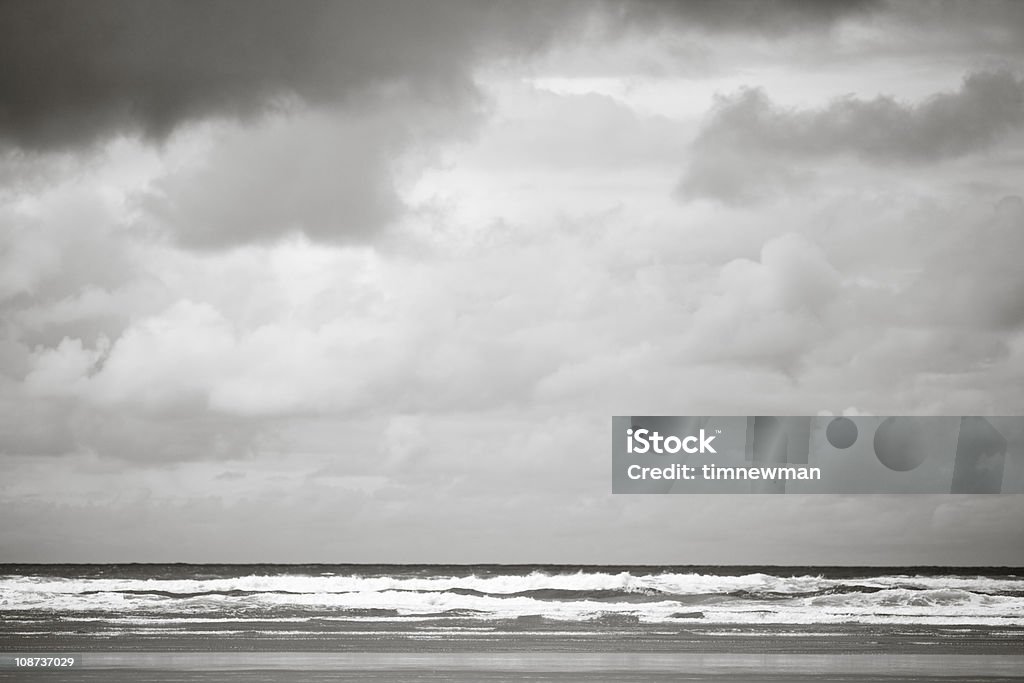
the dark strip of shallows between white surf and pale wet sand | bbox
[0,620,1024,655]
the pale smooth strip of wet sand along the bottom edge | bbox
[0,651,1024,681]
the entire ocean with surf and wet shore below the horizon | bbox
[0,564,1024,681]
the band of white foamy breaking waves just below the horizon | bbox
[0,571,1024,626]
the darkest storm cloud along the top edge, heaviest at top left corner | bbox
[0,0,869,148]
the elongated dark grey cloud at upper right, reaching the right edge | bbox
[680,71,1024,202]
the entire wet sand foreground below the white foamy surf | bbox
[0,624,1024,682]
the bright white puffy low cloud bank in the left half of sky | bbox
[25,301,403,415]
